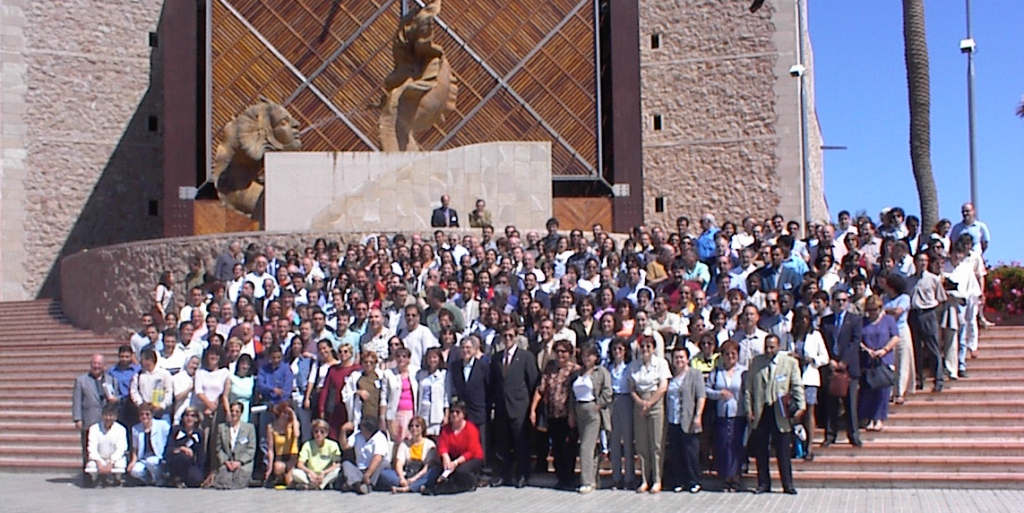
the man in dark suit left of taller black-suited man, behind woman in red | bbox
[447,334,490,452]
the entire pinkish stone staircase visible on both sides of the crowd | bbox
[0,301,1024,488]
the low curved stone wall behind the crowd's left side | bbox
[60,229,480,337]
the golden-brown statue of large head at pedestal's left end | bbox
[213,101,302,222]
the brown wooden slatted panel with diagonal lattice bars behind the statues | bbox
[210,0,599,176]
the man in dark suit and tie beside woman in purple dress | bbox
[820,290,863,447]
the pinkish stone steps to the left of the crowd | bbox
[0,300,119,471]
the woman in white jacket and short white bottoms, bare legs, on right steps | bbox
[782,305,828,461]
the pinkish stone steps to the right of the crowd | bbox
[794,328,1024,489]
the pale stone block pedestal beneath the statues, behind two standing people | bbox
[265,142,552,231]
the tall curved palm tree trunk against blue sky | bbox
[903,0,939,230]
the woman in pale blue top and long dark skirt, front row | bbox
[707,340,746,491]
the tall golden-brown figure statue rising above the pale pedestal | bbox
[378,0,459,152]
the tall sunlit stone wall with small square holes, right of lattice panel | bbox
[640,0,824,226]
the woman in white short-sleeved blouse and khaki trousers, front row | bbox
[630,336,672,494]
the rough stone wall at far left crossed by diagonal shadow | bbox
[0,0,164,300]
